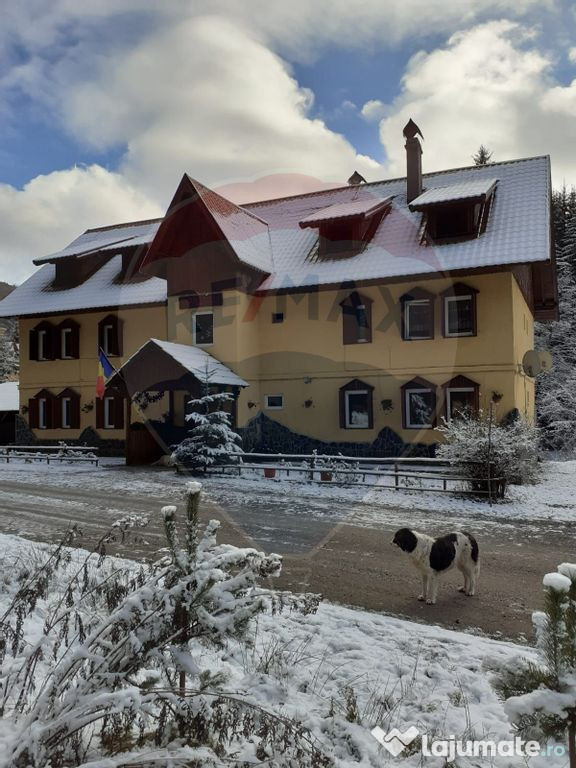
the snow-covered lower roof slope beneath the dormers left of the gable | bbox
[0,256,166,317]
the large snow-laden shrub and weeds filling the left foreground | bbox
[0,483,329,768]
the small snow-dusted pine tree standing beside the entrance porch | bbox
[172,370,242,472]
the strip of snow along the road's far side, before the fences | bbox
[0,459,576,527]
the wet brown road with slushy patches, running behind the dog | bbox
[0,480,576,640]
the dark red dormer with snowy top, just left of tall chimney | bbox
[300,194,391,258]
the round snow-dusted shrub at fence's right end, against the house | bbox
[437,412,540,492]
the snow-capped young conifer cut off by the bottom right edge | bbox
[495,563,576,765]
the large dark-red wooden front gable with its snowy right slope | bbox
[142,174,273,274]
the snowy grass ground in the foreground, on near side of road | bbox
[0,534,567,768]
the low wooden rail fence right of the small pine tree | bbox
[202,453,506,499]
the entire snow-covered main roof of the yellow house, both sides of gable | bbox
[0,156,550,317]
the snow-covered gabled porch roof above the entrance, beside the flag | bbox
[109,339,248,396]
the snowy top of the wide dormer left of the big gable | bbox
[34,219,162,264]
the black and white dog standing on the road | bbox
[392,528,480,605]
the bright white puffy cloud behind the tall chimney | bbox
[380,21,576,184]
